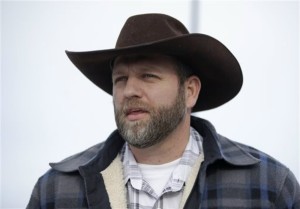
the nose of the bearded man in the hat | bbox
[123,76,142,98]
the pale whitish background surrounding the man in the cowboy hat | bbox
[0,0,300,208]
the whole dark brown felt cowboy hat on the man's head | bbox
[66,14,243,112]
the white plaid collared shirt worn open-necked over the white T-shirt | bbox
[121,127,203,209]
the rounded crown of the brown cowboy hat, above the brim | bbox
[116,14,189,48]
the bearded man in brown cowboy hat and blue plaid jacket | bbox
[27,14,300,209]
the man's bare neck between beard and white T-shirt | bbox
[130,114,190,165]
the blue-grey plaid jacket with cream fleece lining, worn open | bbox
[27,117,300,209]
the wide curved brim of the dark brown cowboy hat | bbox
[66,34,243,112]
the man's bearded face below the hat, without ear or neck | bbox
[112,55,186,148]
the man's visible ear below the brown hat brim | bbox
[185,76,201,109]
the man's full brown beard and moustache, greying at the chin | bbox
[114,87,186,148]
